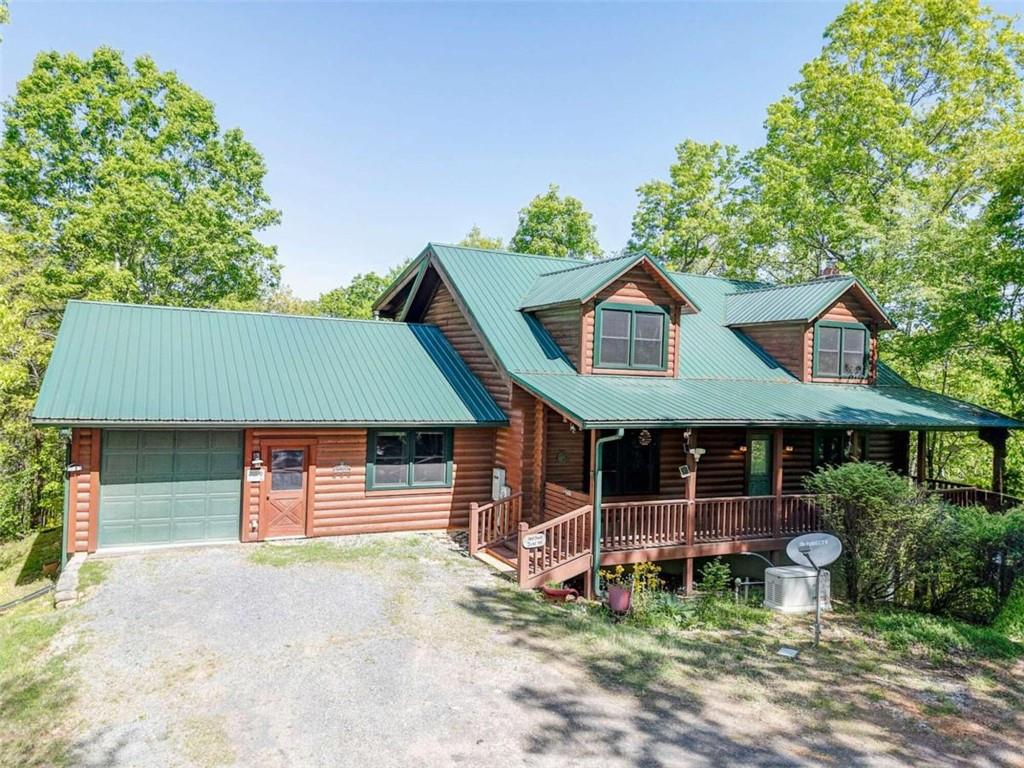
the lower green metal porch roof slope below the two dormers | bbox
[514,374,1024,429]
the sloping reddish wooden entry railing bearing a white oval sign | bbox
[516,504,594,588]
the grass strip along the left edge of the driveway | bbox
[0,530,72,768]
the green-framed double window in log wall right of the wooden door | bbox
[367,429,452,489]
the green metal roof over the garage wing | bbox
[33,301,507,425]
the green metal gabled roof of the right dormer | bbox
[725,276,892,326]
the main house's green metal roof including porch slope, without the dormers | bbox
[423,244,1024,429]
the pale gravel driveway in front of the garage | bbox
[61,535,999,768]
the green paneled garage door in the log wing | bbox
[98,430,242,547]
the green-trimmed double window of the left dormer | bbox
[594,302,669,371]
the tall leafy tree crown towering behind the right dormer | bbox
[753,0,1024,307]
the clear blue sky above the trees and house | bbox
[0,0,933,298]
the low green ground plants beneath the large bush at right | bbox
[857,610,1024,659]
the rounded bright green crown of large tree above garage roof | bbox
[0,48,280,305]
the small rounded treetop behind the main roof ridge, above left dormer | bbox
[509,184,601,259]
